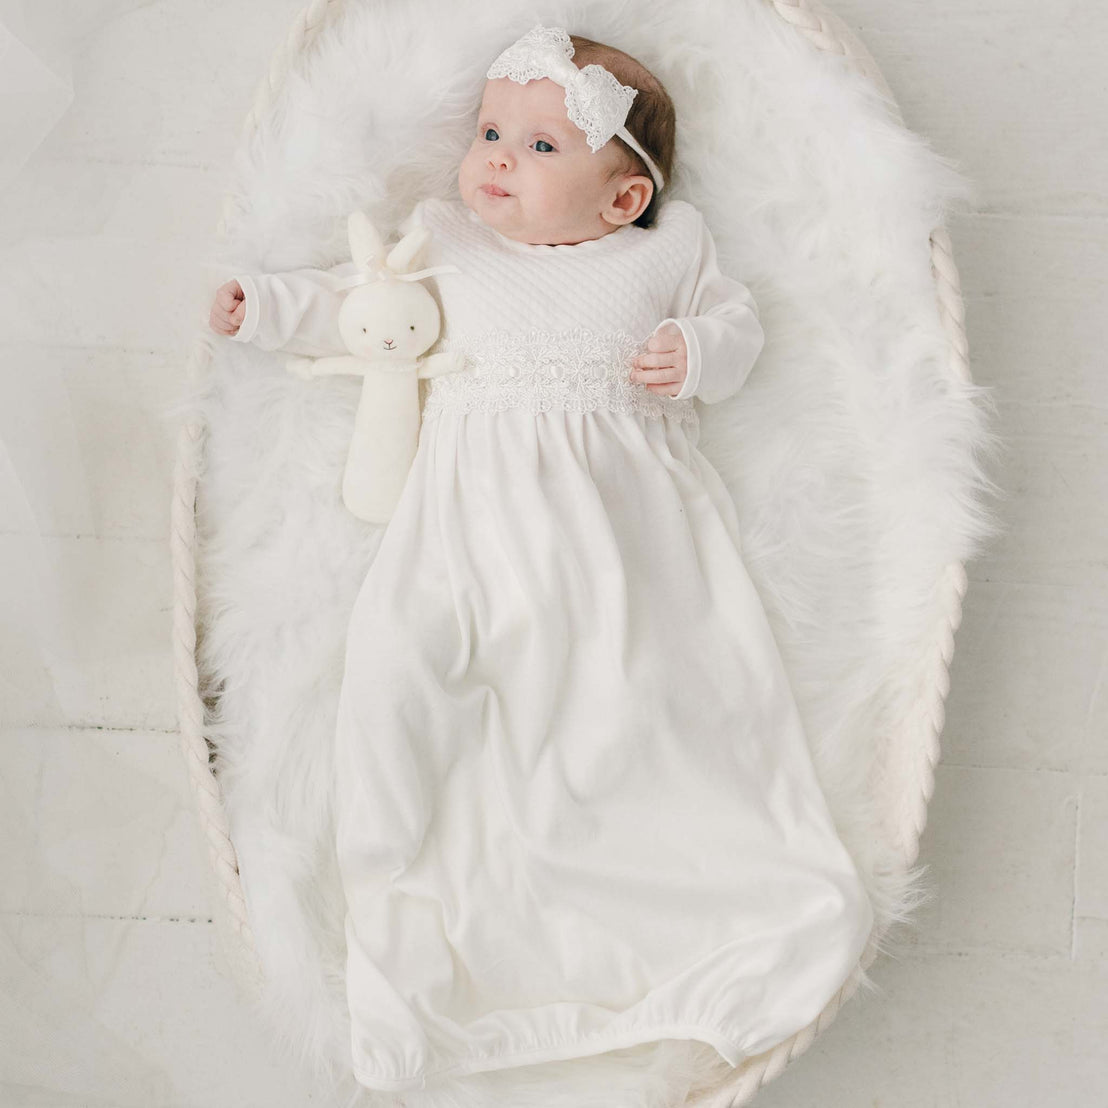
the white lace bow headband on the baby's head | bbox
[485,23,665,191]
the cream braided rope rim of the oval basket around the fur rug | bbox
[171,0,971,1108]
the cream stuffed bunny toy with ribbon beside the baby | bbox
[285,212,465,523]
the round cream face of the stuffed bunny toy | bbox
[338,278,441,361]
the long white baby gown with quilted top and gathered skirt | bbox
[236,199,873,1090]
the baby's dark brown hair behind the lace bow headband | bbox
[570,34,677,227]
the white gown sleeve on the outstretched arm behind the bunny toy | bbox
[230,201,422,358]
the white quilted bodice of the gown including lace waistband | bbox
[413,198,699,420]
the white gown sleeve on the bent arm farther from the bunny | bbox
[655,215,766,404]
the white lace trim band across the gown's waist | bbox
[423,327,697,421]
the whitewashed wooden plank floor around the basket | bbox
[0,0,1108,1108]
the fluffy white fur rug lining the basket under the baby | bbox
[168,0,995,1108]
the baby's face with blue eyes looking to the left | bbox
[458,76,649,244]
